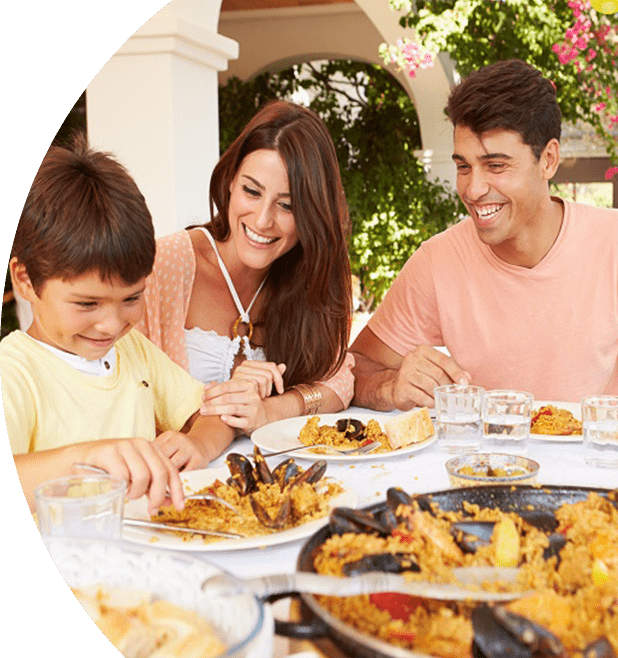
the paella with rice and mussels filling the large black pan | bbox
[312,489,618,658]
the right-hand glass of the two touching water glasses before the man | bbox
[482,390,534,455]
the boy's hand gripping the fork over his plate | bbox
[81,438,184,514]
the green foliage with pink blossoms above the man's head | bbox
[381,0,618,161]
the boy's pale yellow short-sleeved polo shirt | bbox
[0,330,204,454]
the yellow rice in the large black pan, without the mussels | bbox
[314,493,618,658]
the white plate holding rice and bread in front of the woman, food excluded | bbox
[251,412,436,462]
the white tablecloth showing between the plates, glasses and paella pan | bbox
[152,407,618,658]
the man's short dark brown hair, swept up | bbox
[446,59,562,160]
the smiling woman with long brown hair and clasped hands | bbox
[138,101,354,433]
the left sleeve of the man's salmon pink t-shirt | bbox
[368,245,443,356]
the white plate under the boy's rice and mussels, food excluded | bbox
[122,466,357,552]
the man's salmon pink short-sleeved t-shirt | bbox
[369,196,618,402]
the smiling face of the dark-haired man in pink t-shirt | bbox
[453,126,557,257]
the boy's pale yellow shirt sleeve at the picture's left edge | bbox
[1,359,36,455]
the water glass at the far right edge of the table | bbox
[582,395,618,468]
